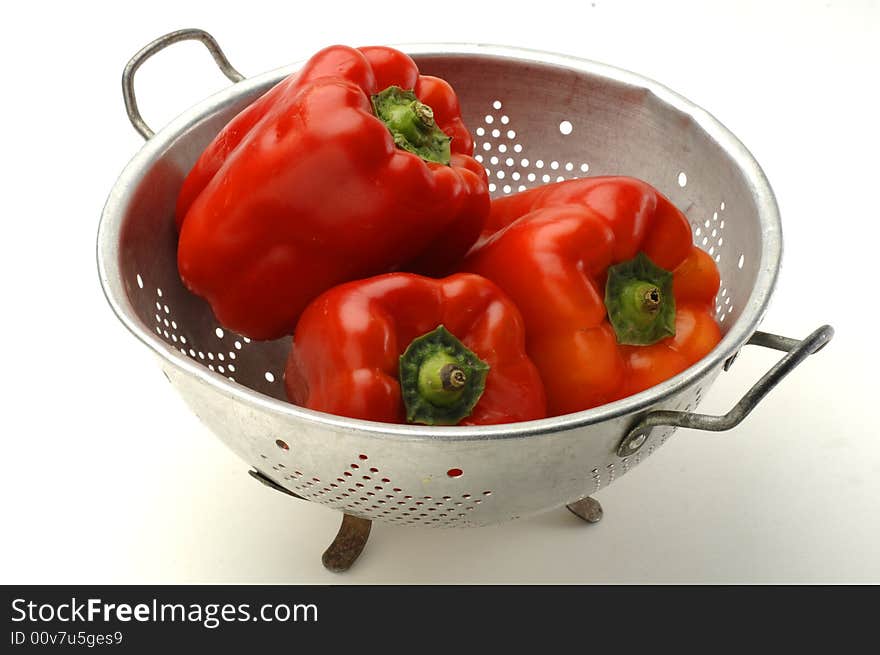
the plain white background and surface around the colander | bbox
[0,0,880,583]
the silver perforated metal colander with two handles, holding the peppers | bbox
[98,30,833,572]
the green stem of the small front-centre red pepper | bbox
[398,325,489,425]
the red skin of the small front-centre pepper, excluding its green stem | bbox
[284,273,546,425]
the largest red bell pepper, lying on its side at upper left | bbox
[176,46,489,339]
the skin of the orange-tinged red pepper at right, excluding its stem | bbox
[462,177,721,415]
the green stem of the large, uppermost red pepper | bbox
[371,86,451,165]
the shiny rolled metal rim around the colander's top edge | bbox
[96,43,782,441]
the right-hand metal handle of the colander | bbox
[617,325,834,457]
